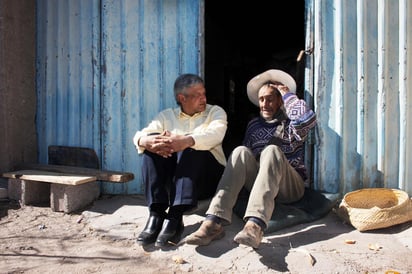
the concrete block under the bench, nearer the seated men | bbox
[50,182,100,213]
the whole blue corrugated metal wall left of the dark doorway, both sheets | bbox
[37,0,203,194]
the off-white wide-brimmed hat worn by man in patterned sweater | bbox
[247,69,296,106]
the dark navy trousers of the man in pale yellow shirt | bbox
[142,148,224,209]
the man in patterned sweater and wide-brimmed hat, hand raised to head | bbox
[184,69,316,248]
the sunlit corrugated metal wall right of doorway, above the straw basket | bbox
[306,0,412,195]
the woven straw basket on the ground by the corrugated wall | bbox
[337,188,412,231]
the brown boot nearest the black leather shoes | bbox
[185,220,225,245]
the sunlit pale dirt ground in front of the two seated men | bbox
[0,196,412,273]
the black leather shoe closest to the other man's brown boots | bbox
[155,219,184,247]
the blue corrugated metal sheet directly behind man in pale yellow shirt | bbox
[101,1,201,193]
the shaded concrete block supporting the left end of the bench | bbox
[8,179,50,205]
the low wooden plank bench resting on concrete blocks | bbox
[1,164,134,213]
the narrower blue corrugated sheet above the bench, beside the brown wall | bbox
[36,0,101,163]
